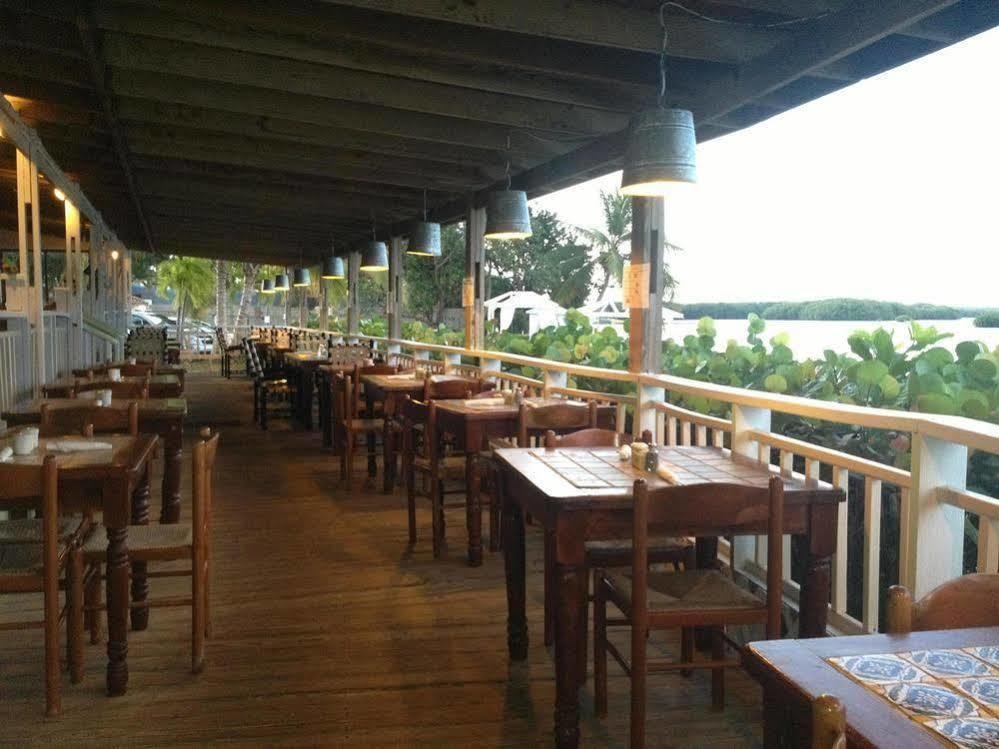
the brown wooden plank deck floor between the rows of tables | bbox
[0,375,761,748]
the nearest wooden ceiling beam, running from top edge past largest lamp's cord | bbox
[316,0,784,63]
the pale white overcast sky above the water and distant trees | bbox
[533,29,999,306]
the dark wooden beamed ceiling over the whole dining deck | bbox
[0,0,999,262]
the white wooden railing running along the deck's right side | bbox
[264,324,999,633]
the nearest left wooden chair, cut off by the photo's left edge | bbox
[0,455,83,715]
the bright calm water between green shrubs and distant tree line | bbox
[664,317,999,359]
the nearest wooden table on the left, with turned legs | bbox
[0,427,159,696]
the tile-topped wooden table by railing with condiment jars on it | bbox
[495,447,844,747]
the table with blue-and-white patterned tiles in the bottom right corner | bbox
[743,627,999,749]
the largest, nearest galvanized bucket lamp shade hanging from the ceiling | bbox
[621,107,697,197]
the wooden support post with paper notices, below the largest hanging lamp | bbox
[625,198,665,374]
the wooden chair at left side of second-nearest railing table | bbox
[402,398,467,559]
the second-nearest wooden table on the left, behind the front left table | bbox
[2,398,187,523]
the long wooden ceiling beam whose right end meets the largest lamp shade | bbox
[105,34,627,135]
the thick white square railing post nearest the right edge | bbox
[899,434,968,598]
